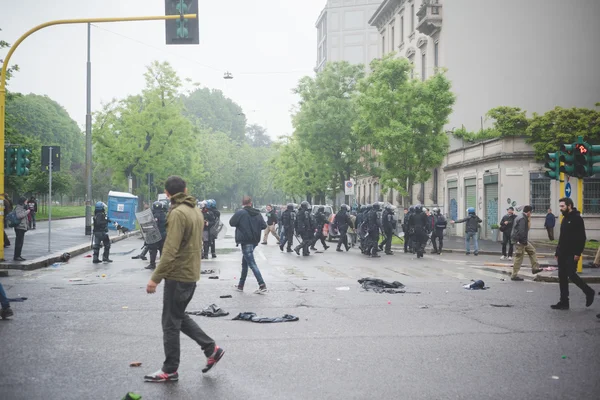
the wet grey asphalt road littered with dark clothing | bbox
[0,217,600,400]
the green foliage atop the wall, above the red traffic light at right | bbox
[527,104,600,160]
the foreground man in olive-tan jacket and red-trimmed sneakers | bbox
[144,176,225,382]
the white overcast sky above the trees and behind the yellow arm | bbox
[0,0,326,137]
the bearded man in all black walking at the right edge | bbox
[548,197,596,310]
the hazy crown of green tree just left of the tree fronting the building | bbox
[293,61,365,203]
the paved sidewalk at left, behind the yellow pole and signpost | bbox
[0,218,142,270]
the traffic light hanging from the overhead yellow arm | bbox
[165,0,200,44]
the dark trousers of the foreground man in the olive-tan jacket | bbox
[162,279,215,374]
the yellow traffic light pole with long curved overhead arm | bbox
[0,14,198,261]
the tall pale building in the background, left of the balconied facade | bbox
[315,0,382,71]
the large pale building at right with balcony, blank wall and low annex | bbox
[357,0,600,238]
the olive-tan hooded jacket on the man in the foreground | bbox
[151,193,204,284]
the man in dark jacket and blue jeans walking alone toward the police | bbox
[229,196,267,294]
